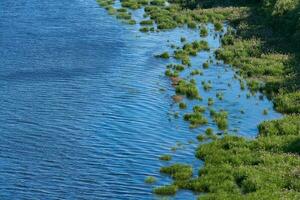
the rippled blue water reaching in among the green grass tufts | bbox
[0,0,279,200]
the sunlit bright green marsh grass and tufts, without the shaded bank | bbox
[98,0,300,199]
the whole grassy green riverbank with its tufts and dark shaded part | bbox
[97,1,300,199]
